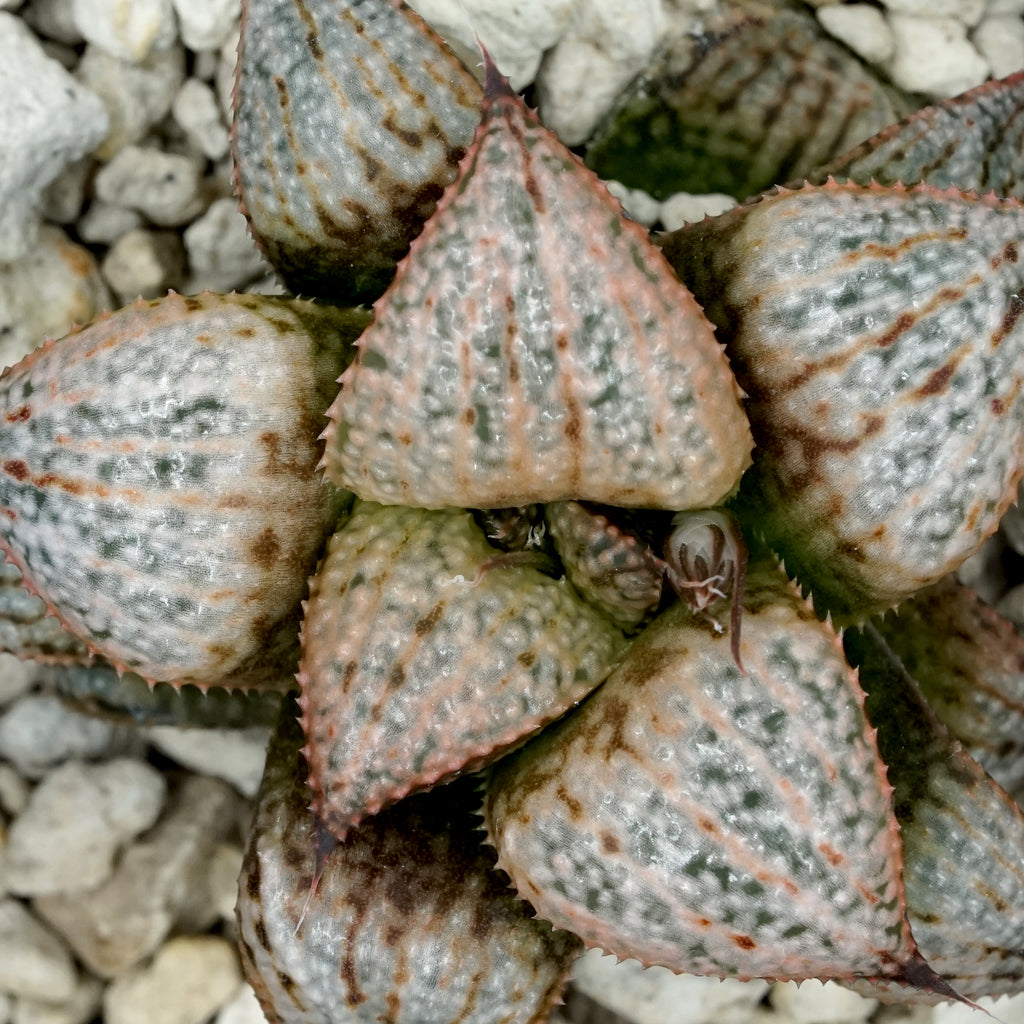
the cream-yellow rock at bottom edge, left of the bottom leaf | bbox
[103,935,242,1024]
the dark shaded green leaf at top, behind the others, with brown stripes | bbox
[587,3,903,199]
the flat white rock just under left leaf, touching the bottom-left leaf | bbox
[144,725,270,797]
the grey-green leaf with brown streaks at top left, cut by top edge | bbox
[232,0,480,303]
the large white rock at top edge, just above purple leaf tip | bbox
[410,0,573,89]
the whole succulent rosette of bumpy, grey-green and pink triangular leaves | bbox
[0,0,1024,1022]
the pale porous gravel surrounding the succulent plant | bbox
[0,0,1024,1024]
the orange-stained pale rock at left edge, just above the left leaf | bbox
[0,224,113,370]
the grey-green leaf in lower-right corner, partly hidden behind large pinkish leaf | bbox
[847,624,1024,1001]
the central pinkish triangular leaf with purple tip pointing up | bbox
[327,70,750,509]
